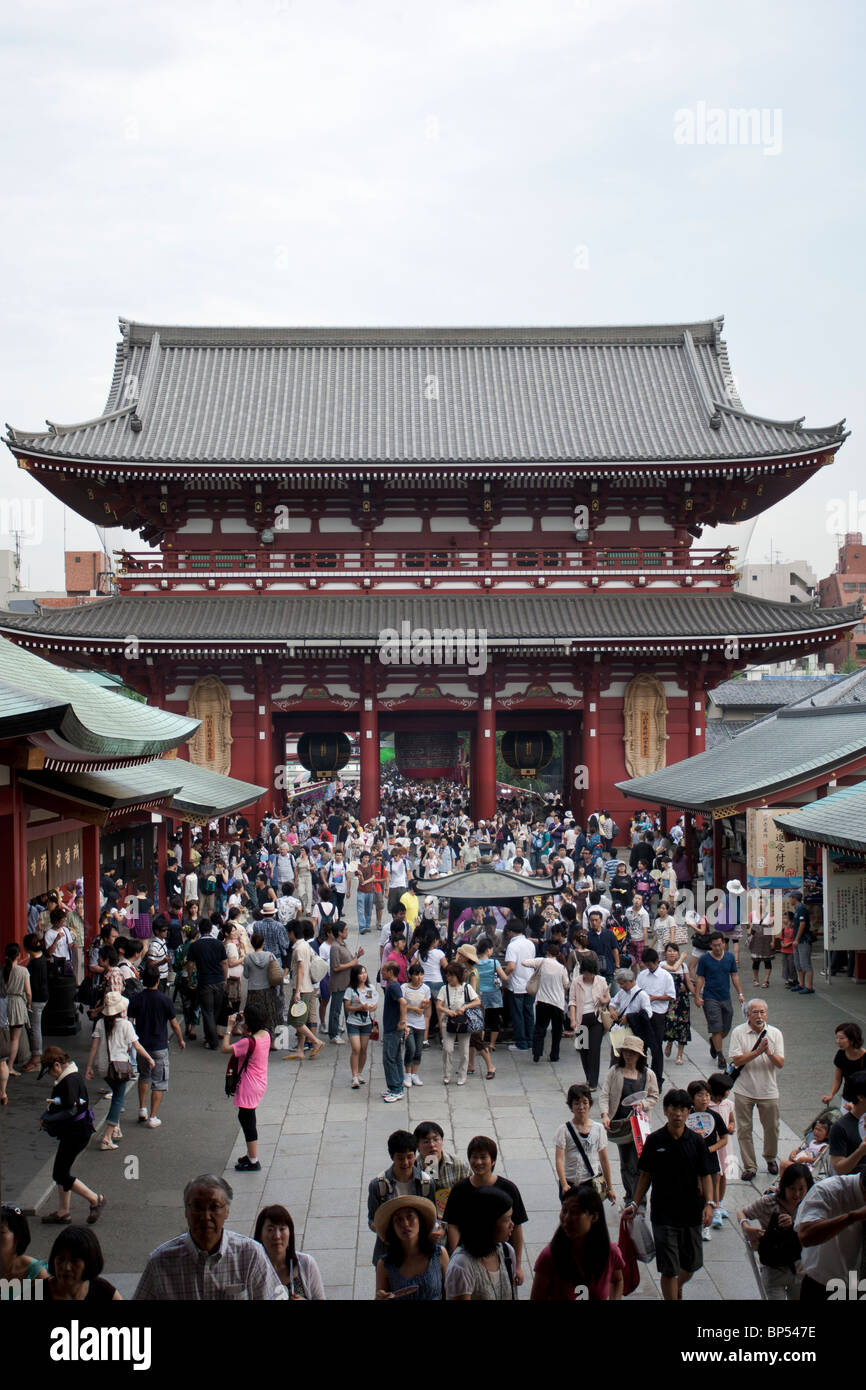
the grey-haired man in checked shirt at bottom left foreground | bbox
[135,1173,288,1302]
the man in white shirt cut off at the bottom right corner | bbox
[794,1172,866,1302]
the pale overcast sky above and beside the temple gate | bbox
[0,0,866,587]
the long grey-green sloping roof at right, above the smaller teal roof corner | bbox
[617,705,866,810]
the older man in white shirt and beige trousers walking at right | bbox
[730,999,785,1183]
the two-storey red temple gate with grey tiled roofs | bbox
[0,318,860,823]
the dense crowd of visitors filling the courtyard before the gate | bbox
[0,778,866,1300]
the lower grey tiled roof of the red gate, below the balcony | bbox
[0,591,859,647]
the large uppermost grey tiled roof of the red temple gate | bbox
[8,318,845,466]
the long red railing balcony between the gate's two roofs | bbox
[115,546,737,592]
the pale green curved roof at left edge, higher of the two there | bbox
[0,636,199,758]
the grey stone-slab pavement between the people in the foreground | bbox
[0,923,866,1301]
